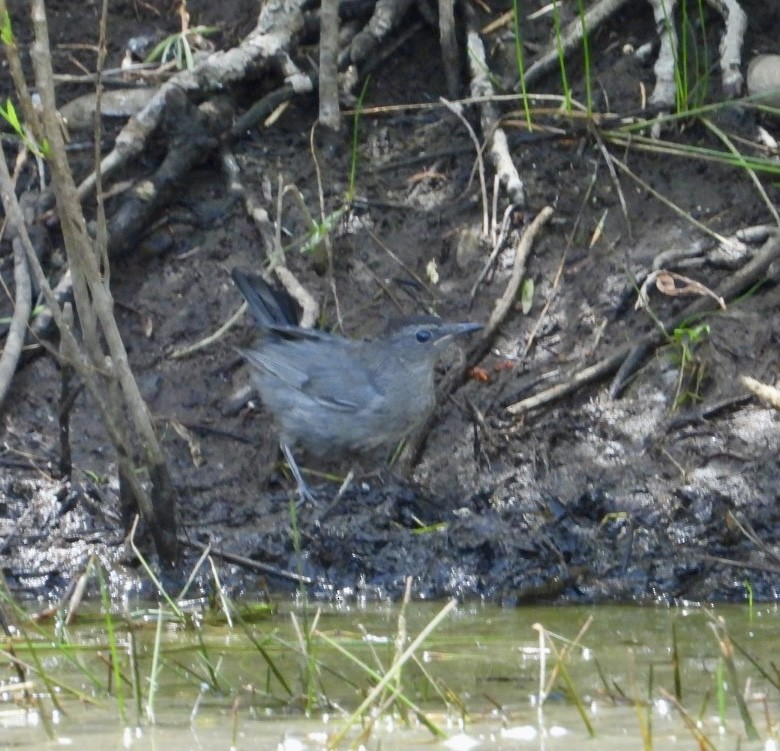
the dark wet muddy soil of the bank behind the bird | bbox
[0,0,780,604]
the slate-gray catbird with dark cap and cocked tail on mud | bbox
[232,269,482,497]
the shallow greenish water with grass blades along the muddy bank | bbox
[0,603,780,751]
